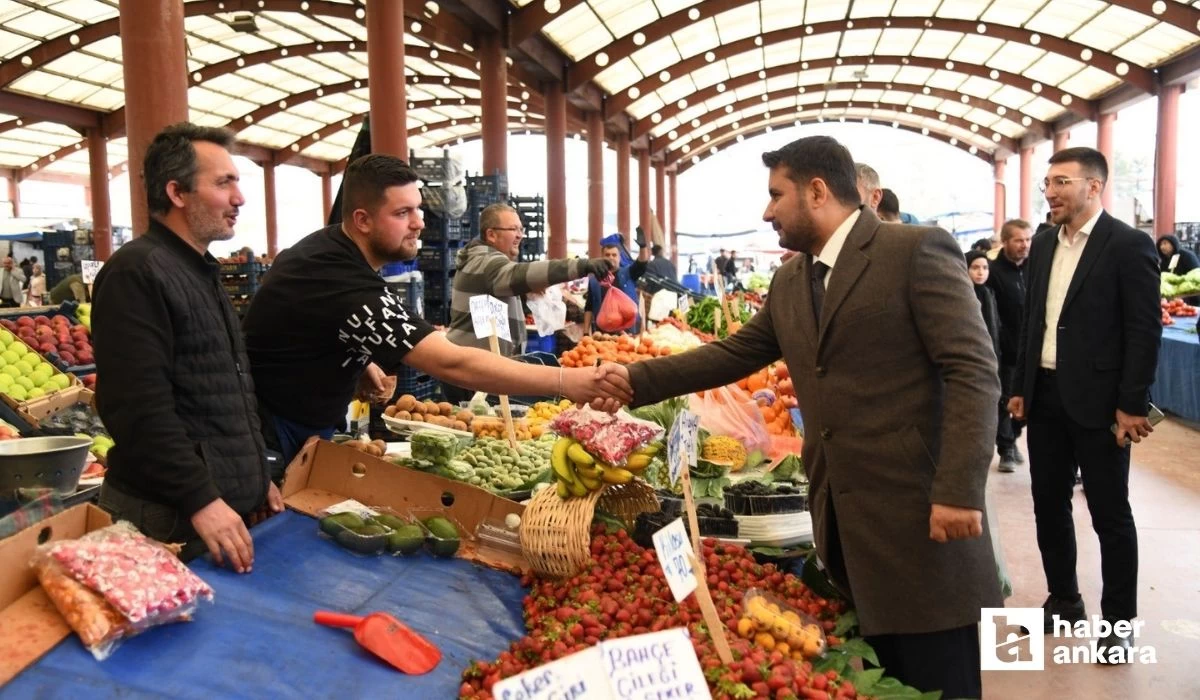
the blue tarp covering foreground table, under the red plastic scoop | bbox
[0,511,524,699]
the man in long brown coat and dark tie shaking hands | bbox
[600,137,1002,698]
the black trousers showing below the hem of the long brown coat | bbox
[866,624,983,699]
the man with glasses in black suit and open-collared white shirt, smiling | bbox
[1009,148,1163,659]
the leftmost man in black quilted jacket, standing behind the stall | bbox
[92,122,274,573]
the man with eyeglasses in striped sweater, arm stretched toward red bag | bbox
[443,203,613,401]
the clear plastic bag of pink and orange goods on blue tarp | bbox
[31,522,212,660]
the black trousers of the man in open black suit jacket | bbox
[1028,370,1138,620]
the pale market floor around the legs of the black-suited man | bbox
[983,419,1200,700]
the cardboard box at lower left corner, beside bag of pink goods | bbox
[0,503,113,686]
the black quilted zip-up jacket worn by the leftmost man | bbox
[92,221,269,517]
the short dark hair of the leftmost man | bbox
[142,121,238,216]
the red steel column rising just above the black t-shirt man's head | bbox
[364,0,408,158]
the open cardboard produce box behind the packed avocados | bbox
[282,438,528,572]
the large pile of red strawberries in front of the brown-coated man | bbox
[458,531,858,700]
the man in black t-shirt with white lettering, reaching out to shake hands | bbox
[245,154,632,462]
